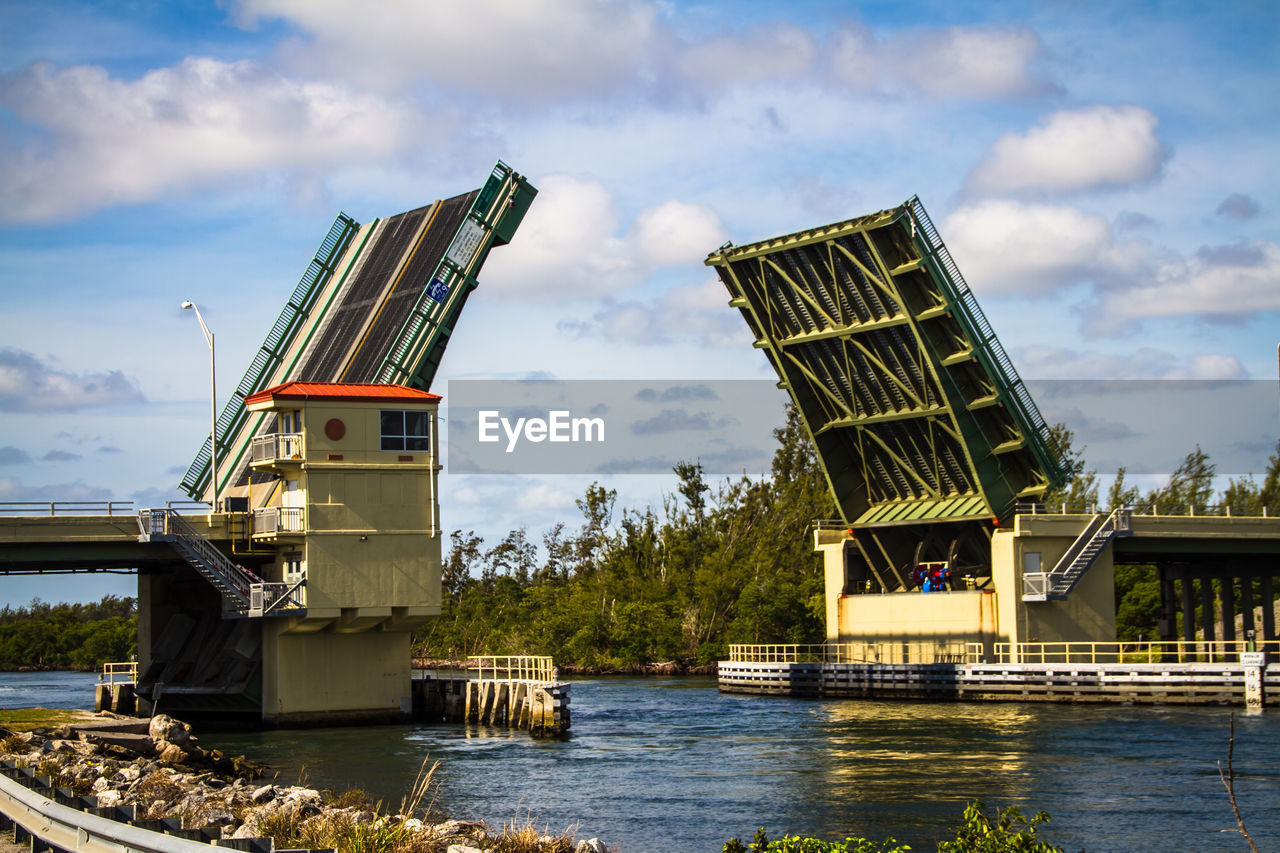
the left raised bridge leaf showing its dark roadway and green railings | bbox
[180,163,538,500]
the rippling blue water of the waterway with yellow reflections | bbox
[0,675,1280,853]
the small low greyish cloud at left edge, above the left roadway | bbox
[0,348,143,411]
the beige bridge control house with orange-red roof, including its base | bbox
[244,382,440,722]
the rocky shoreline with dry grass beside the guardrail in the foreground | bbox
[0,713,609,853]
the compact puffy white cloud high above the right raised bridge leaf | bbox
[965,106,1169,192]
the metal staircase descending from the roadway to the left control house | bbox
[138,508,306,619]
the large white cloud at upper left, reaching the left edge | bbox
[0,58,421,222]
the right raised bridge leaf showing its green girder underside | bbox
[707,199,1064,524]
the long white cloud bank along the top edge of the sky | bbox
[236,0,1052,106]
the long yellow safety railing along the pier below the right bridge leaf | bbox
[728,640,1280,663]
